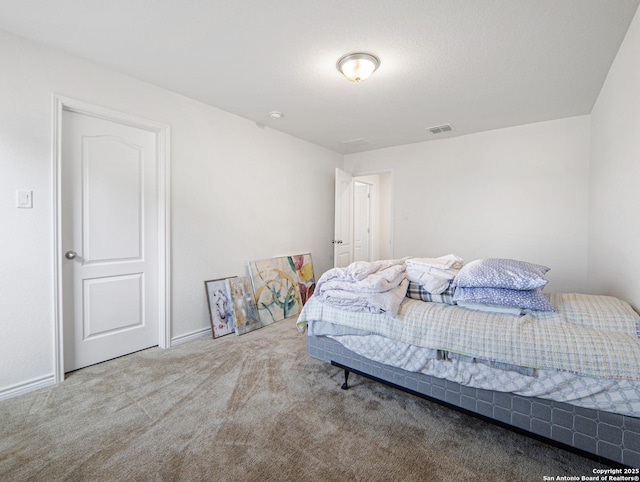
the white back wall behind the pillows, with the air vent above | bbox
[345,116,589,292]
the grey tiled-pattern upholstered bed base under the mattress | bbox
[306,336,640,467]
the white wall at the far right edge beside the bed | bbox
[589,11,640,310]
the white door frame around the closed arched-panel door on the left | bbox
[52,94,171,383]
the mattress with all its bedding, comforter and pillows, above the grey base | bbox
[297,255,640,416]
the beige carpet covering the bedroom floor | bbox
[0,319,600,481]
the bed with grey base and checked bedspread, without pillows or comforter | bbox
[297,264,640,467]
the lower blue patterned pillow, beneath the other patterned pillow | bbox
[453,286,554,311]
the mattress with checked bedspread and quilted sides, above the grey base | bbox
[297,294,640,417]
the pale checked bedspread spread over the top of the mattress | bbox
[297,293,640,380]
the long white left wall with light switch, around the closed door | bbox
[0,32,343,397]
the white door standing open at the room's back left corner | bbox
[333,168,353,268]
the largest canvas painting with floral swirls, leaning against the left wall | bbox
[249,257,302,325]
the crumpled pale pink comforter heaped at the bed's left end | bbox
[313,259,409,316]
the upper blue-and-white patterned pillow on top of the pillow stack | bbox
[453,258,549,290]
